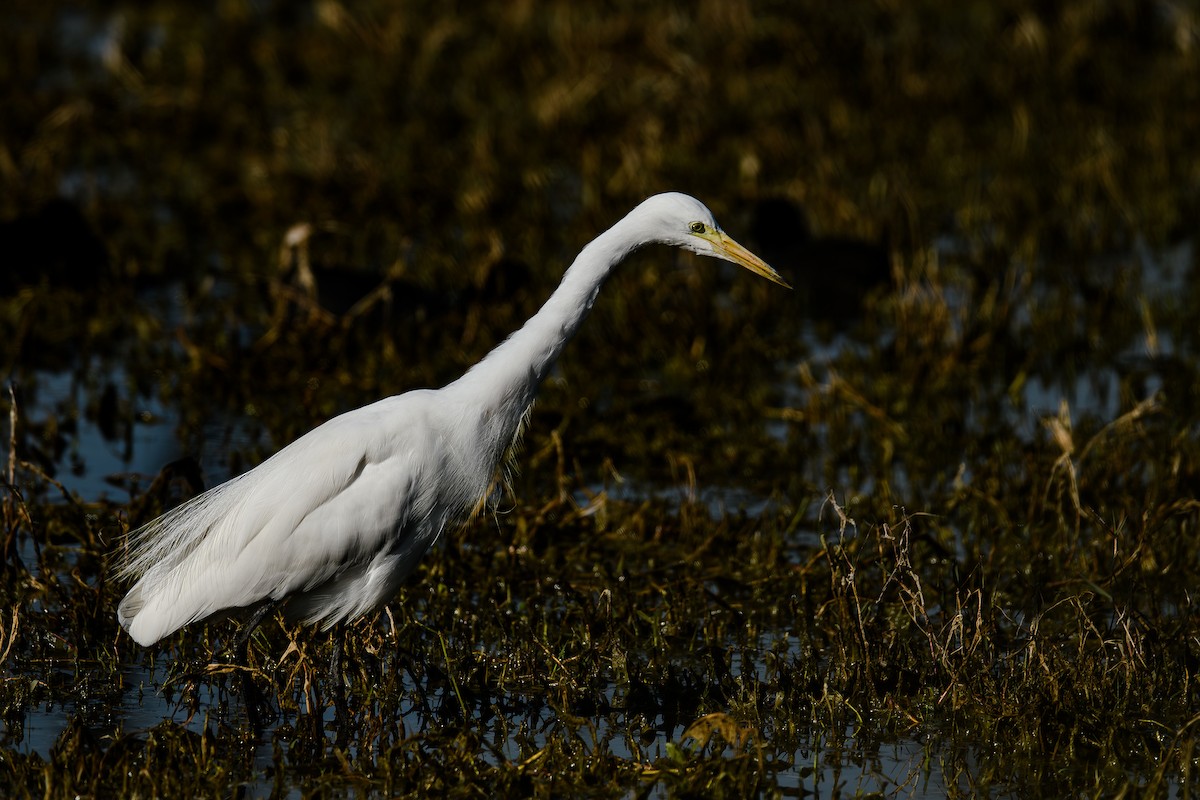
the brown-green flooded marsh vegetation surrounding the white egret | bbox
[0,0,1200,798]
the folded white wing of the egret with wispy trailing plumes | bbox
[119,392,448,642]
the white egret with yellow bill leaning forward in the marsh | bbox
[116,193,787,646]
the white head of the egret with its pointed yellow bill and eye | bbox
[630,192,792,289]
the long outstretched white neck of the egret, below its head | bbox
[446,218,641,447]
